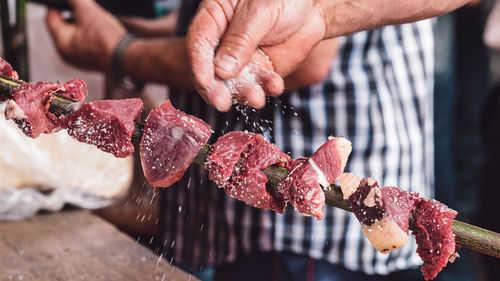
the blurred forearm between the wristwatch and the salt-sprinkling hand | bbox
[123,38,193,89]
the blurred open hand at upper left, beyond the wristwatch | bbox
[46,0,126,71]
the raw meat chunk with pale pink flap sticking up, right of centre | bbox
[280,137,351,220]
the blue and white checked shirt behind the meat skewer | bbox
[162,1,433,274]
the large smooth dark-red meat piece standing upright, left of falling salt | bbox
[141,100,211,187]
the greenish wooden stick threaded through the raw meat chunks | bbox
[0,76,500,258]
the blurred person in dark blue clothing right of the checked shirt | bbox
[428,1,490,281]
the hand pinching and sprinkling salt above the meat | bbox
[187,0,326,99]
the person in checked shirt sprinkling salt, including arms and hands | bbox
[47,0,476,280]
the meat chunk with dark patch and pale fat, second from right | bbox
[349,179,415,254]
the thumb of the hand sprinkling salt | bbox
[214,6,271,79]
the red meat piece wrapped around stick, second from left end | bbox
[5,79,87,138]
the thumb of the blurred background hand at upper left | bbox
[46,9,75,49]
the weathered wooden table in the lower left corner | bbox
[0,210,197,281]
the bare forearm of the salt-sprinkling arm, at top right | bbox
[319,0,470,38]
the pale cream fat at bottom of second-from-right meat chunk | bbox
[361,215,409,254]
